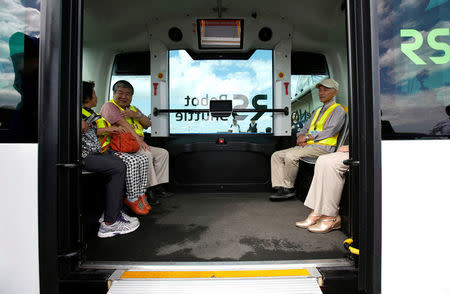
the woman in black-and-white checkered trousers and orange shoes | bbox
[82,82,151,215]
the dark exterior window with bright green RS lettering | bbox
[377,0,450,139]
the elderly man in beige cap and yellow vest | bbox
[270,79,345,201]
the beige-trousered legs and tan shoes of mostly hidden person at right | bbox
[295,145,349,233]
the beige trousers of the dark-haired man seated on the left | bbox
[138,146,169,187]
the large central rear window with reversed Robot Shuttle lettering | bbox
[169,50,273,134]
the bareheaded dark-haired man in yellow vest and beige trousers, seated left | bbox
[100,80,172,200]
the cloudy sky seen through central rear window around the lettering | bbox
[169,50,272,133]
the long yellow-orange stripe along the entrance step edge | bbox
[121,269,309,279]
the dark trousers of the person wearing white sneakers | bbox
[83,152,126,223]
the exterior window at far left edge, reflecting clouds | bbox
[0,1,41,143]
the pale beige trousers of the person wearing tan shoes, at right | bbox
[305,152,348,216]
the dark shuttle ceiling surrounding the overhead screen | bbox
[83,0,346,52]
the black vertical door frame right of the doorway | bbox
[347,0,381,293]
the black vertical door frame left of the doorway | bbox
[38,0,82,294]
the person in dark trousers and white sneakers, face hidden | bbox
[81,109,139,238]
